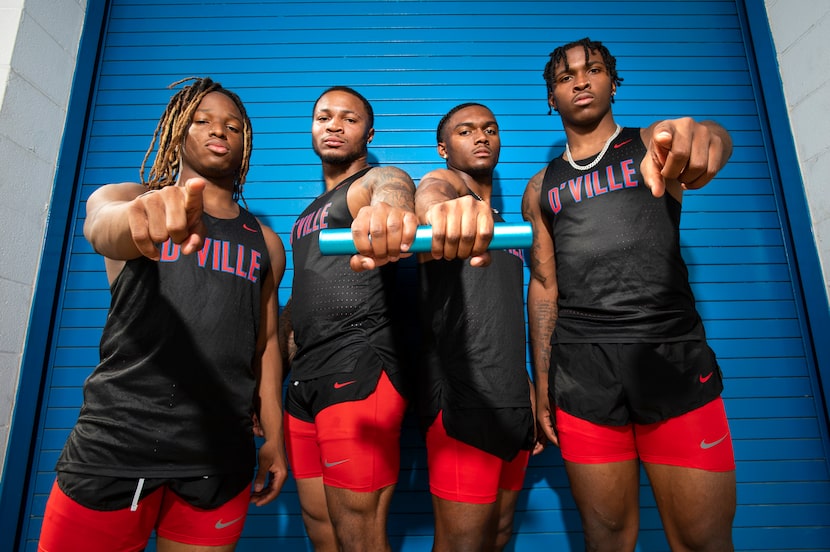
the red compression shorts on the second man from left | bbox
[284,372,406,492]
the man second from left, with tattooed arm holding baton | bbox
[281,86,418,552]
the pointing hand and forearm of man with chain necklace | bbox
[640,117,732,200]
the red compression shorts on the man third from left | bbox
[426,412,530,504]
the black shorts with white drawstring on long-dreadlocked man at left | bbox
[57,471,253,511]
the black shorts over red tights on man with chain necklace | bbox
[548,341,723,426]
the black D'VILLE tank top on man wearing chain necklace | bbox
[540,128,703,343]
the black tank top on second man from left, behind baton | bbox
[291,167,399,381]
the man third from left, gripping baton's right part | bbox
[415,103,535,552]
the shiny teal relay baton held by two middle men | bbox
[320,222,533,255]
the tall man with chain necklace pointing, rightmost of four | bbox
[522,38,735,551]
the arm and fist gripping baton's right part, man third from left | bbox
[415,169,493,266]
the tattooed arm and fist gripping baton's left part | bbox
[347,167,418,272]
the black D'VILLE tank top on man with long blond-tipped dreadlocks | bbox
[57,208,271,477]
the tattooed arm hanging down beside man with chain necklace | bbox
[522,170,559,445]
